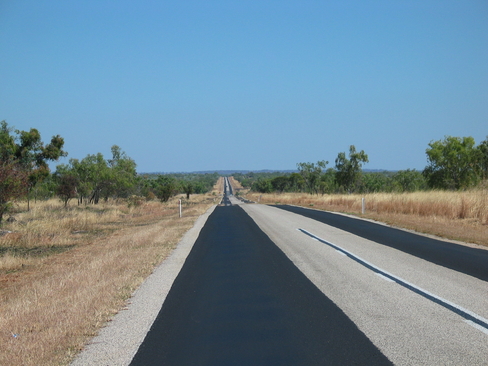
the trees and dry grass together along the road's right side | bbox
[234,136,488,246]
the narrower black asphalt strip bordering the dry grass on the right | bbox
[275,205,488,281]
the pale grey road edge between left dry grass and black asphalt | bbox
[71,205,216,366]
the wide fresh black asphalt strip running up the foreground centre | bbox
[131,206,391,366]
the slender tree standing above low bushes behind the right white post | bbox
[335,145,369,193]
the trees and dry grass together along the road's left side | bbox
[0,121,223,366]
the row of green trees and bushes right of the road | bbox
[234,136,488,194]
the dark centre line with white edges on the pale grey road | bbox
[297,228,488,334]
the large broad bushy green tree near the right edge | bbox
[422,136,479,190]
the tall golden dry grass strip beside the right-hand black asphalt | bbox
[247,188,488,246]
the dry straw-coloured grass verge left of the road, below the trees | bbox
[0,186,222,365]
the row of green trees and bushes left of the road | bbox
[0,121,219,223]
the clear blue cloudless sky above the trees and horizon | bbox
[0,0,488,172]
